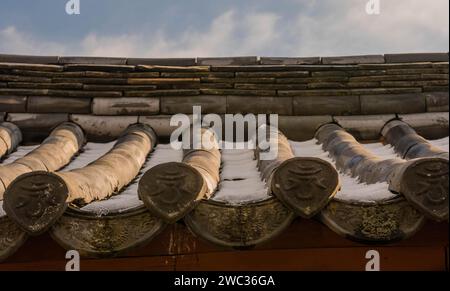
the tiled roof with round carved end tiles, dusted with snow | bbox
[0,53,449,260]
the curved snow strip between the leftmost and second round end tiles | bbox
[80,144,183,216]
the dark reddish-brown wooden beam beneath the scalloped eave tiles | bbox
[0,219,448,271]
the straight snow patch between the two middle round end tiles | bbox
[211,149,270,205]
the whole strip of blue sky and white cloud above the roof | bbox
[0,0,449,57]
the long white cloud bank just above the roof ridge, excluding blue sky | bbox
[0,0,449,57]
